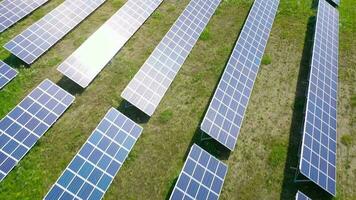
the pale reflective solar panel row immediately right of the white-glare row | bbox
[121,0,221,116]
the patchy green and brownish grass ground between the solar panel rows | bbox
[0,0,356,200]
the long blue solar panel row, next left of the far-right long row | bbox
[201,0,279,150]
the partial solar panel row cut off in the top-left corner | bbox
[0,0,48,33]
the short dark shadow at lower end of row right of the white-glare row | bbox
[117,100,150,124]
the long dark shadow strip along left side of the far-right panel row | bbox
[280,0,331,199]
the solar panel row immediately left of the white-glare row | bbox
[4,0,105,64]
